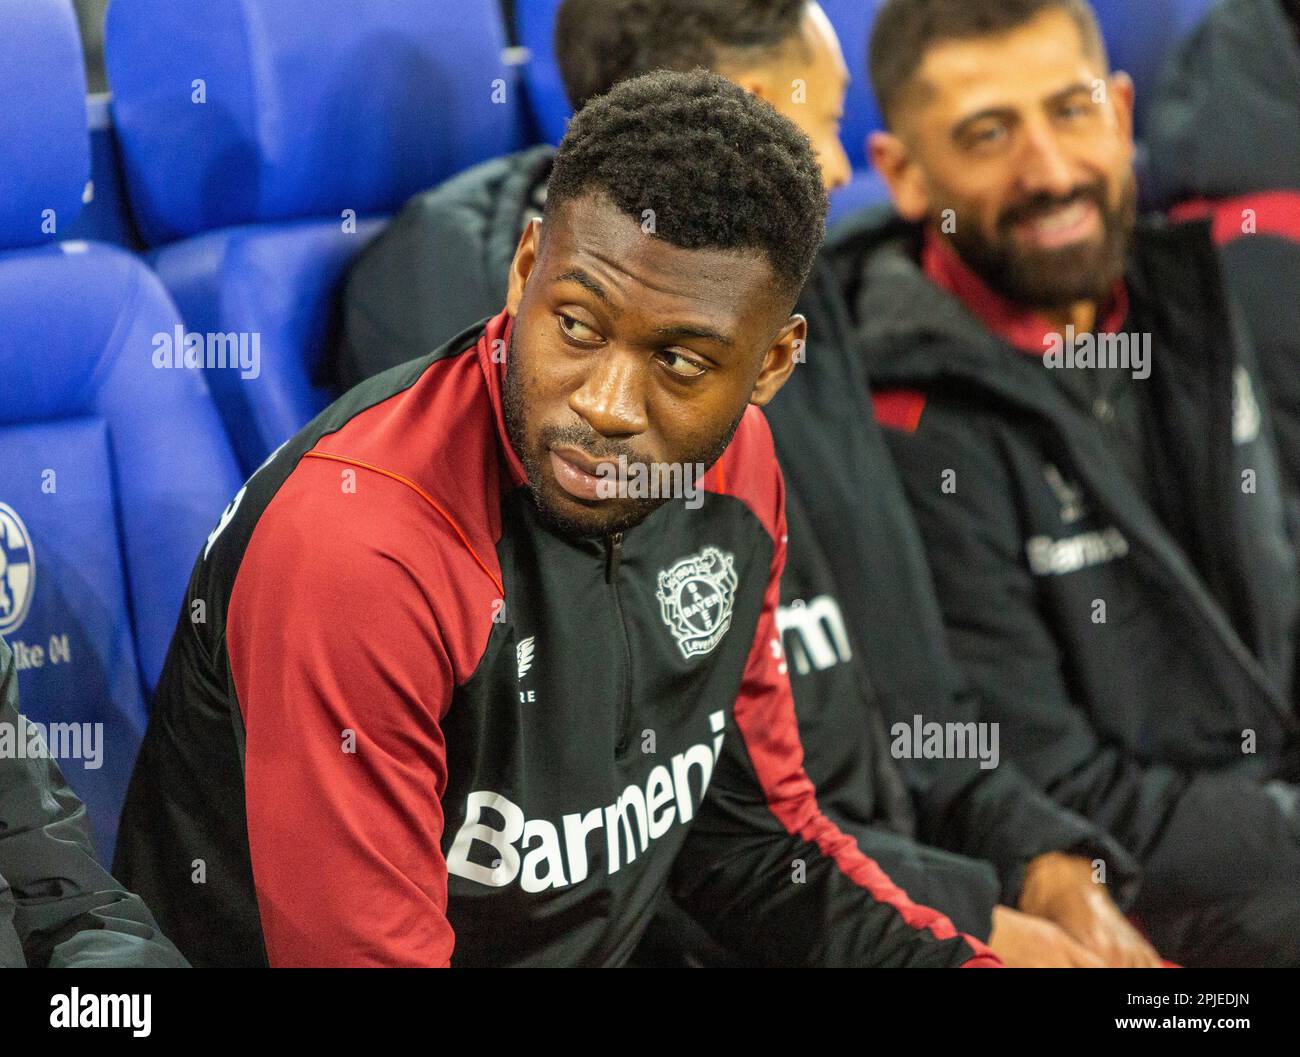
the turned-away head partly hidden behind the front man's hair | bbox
[555,0,850,189]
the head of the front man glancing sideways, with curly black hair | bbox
[503,70,827,538]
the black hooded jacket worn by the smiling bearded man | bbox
[826,212,1300,957]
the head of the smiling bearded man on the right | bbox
[868,0,1138,325]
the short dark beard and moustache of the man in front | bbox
[502,330,749,540]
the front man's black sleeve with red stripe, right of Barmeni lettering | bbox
[671,460,1000,966]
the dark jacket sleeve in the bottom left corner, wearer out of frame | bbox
[0,640,186,969]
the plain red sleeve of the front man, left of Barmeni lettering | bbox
[228,460,489,966]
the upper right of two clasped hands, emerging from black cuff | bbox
[1019,852,1161,969]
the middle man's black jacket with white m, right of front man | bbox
[767,261,1135,937]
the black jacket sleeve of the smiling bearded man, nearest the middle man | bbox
[891,402,1294,898]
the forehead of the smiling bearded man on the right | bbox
[913,10,1106,120]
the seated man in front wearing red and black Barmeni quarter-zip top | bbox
[117,72,997,966]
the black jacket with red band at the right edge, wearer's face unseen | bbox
[1147,0,1300,485]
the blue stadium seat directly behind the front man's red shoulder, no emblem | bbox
[105,0,520,472]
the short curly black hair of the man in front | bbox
[543,70,827,304]
